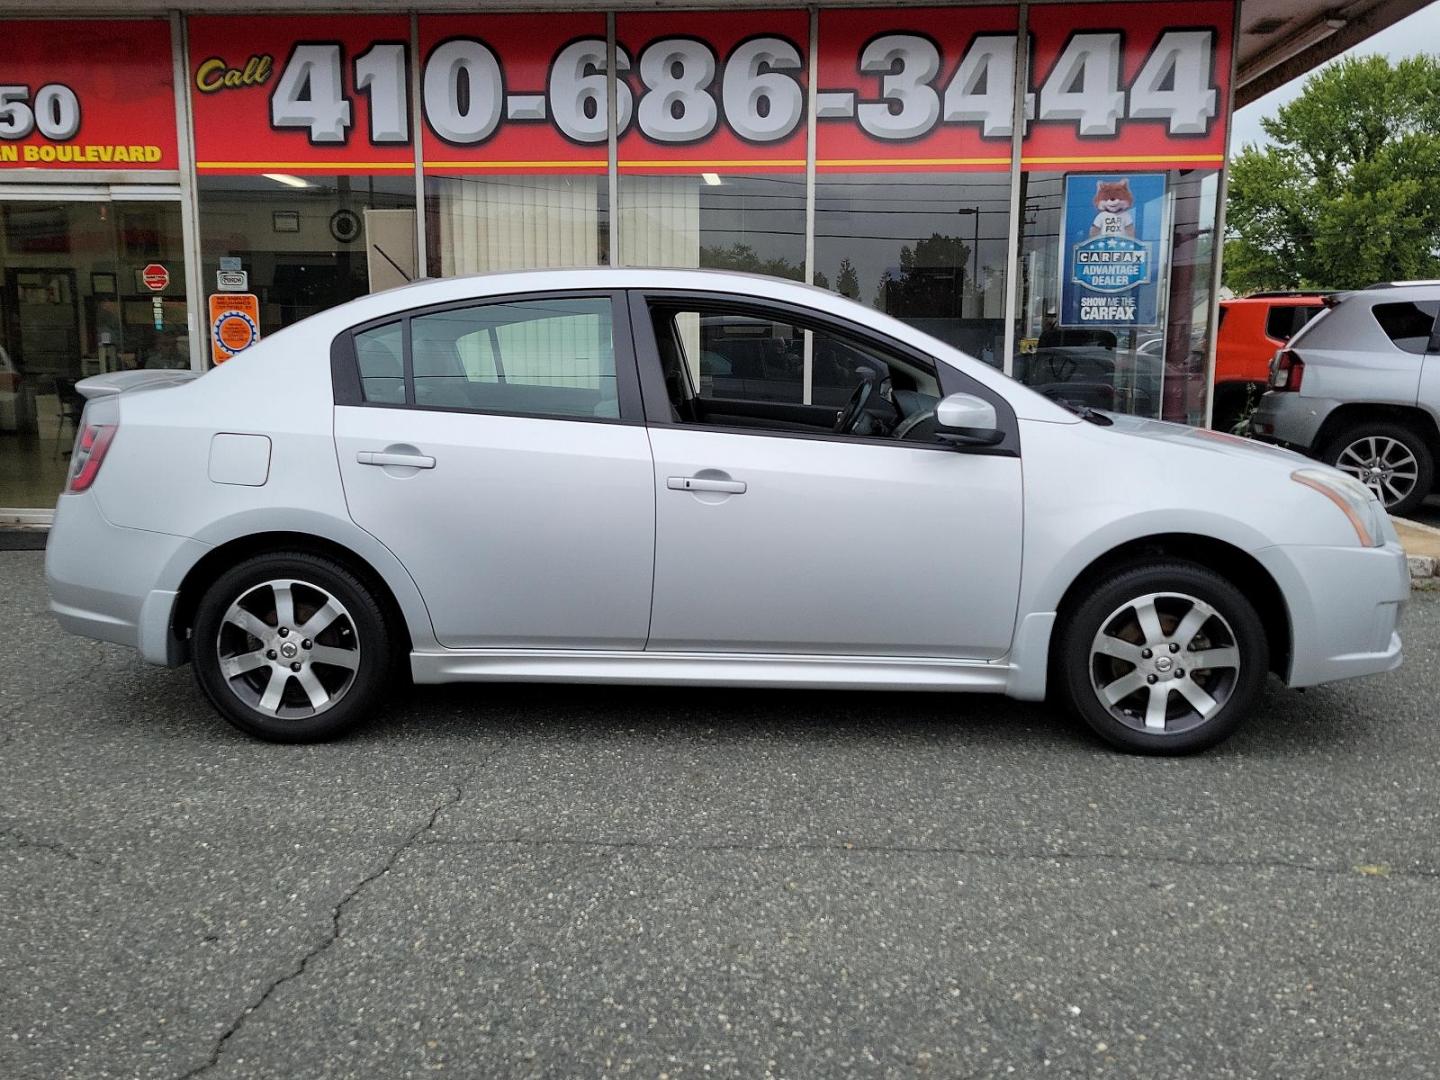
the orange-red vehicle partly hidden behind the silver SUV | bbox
[1211,292,1329,431]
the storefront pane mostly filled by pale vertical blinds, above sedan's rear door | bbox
[425,174,609,276]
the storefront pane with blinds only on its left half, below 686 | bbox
[619,173,805,281]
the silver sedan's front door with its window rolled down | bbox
[631,292,1021,660]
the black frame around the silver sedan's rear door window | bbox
[330,288,645,425]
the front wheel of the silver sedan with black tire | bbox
[1053,560,1270,755]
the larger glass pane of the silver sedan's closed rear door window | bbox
[410,297,621,419]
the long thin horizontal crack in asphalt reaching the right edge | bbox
[420,837,1440,881]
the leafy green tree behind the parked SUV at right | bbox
[1224,56,1440,292]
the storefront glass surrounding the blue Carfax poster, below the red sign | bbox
[1014,170,1218,423]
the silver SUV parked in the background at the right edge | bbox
[1250,281,1440,514]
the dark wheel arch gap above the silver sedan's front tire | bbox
[1048,533,1293,677]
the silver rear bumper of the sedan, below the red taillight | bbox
[45,495,209,667]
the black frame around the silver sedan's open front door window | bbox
[629,288,1020,458]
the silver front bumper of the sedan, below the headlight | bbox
[1256,536,1410,687]
